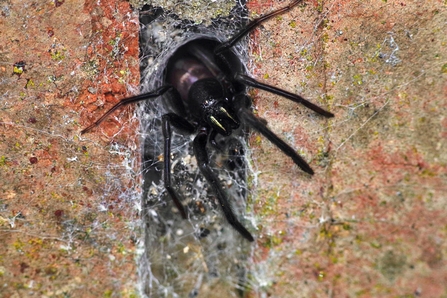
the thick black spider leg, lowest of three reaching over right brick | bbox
[235,94,314,175]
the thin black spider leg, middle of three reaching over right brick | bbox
[235,73,334,118]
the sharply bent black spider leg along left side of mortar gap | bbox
[162,113,194,219]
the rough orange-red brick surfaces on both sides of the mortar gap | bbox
[0,0,447,297]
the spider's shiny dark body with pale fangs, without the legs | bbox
[165,37,245,139]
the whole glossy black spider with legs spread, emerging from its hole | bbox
[81,0,334,241]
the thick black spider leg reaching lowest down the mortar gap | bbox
[194,128,254,242]
